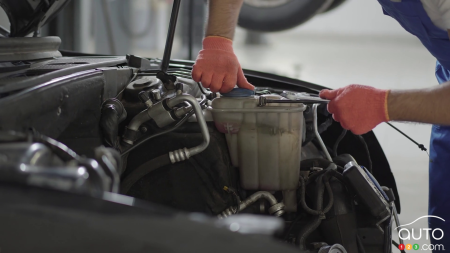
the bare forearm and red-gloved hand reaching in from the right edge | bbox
[320,82,450,134]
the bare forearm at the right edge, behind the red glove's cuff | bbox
[387,82,450,125]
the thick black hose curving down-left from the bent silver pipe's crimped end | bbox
[120,154,171,194]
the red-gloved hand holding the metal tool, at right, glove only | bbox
[320,84,389,135]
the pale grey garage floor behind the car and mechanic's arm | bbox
[235,30,437,245]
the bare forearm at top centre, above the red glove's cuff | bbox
[206,0,244,40]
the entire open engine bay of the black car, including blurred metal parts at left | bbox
[0,56,398,253]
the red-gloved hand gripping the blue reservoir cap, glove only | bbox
[192,36,255,93]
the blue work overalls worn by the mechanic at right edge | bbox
[378,0,450,250]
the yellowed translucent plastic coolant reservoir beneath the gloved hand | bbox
[211,92,306,191]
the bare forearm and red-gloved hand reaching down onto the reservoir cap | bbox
[192,0,254,92]
